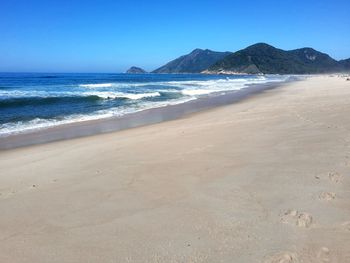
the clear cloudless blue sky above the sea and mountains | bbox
[0,0,350,73]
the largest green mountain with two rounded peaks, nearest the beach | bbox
[205,43,347,74]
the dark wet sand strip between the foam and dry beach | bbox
[0,78,300,151]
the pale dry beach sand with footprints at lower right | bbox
[0,76,350,263]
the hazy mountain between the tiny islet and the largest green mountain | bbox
[153,49,231,73]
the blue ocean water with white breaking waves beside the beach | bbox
[0,73,288,136]
